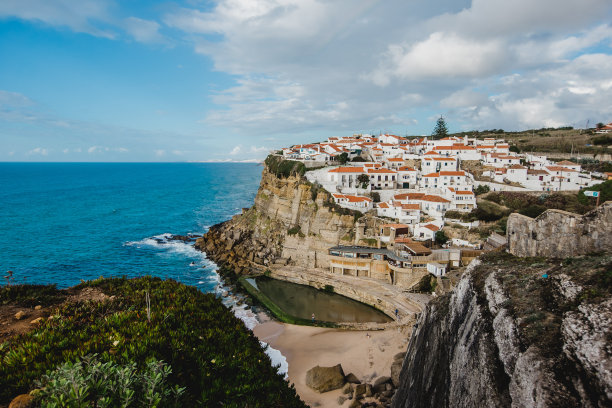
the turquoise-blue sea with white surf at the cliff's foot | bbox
[0,163,262,292]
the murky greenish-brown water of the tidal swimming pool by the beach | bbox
[248,277,392,323]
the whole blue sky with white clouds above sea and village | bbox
[0,0,612,162]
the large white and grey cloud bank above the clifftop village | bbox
[164,0,612,138]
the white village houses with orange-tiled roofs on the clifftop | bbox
[273,126,612,287]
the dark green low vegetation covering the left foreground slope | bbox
[0,277,305,407]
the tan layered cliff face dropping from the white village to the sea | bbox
[196,163,369,273]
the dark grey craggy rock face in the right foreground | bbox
[393,253,612,408]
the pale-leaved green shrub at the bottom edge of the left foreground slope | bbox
[35,354,185,408]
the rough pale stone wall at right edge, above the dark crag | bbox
[507,201,612,258]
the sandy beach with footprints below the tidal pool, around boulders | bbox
[253,321,411,407]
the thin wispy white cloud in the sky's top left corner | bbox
[0,0,114,38]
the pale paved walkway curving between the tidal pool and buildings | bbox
[271,266,431,329]
